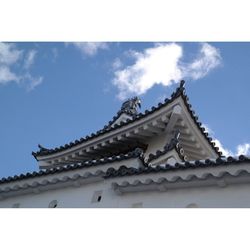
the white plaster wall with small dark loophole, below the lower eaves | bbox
[0,179,250,208]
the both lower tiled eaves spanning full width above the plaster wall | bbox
[0,155,250,199]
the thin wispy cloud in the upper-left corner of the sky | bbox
[0,42,43,91]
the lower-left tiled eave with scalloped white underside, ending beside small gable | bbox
[0,150,144,200]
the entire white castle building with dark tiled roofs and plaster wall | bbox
[0,81,250,208]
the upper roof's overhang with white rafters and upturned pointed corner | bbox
[35,83,220,168]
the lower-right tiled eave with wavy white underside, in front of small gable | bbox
[105,155,250,195]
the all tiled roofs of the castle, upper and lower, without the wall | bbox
[0,81,250,204]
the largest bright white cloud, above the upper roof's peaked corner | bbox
[113,43,182,100]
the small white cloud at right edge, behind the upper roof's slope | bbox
[203,125,250,157]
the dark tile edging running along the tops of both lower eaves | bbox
[0,152,250,185]
